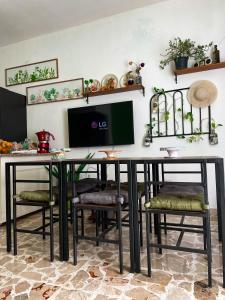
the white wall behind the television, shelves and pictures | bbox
[0,0,225,206]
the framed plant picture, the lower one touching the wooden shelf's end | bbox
[26,78,84,105]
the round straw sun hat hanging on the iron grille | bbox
[187,80,217,108]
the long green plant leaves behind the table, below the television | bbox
[45,153,95,182]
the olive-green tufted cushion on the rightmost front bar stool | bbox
[145,194,208,211]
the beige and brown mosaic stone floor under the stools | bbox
[0,211,225,300]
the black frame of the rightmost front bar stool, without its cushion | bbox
[144,162,212,287]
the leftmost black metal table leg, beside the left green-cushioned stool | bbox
[5,164,12,252]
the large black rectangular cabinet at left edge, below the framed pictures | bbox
[0,88,27,142]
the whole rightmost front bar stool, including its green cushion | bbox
[144,163,212,287]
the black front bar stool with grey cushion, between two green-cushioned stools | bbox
[72,162,125,274]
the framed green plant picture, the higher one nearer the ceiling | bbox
[5,58,59,86]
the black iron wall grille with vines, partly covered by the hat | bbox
[149,88,211,142]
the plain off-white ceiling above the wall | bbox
[0,0,165,47]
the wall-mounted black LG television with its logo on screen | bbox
[68,101,134,148]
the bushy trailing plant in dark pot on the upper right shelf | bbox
[160,37,195,70]
